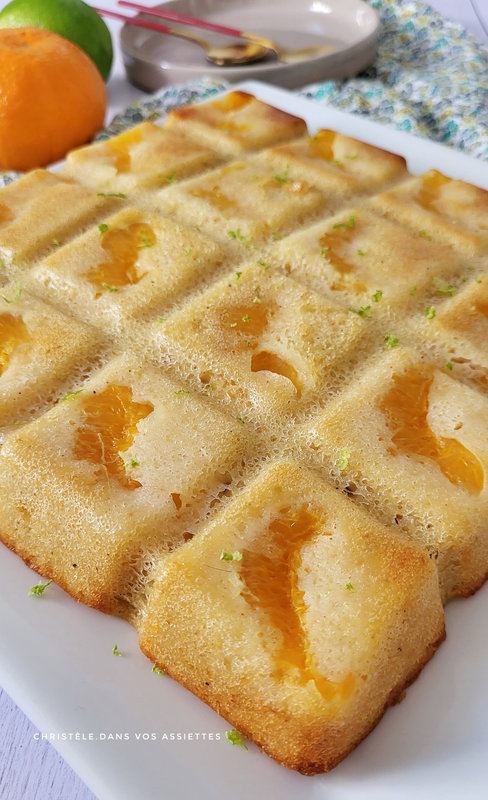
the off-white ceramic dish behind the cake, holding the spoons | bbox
[120,0,380,91]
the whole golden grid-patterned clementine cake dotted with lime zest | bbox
[0,92,488,773]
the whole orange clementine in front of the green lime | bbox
[0,27,107,170]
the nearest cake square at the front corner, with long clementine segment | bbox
[140,461,444,774]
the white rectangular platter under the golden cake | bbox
[0,82,488,800]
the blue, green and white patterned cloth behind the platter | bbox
[0,0,488,185]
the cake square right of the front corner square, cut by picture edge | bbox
[302,340,488,600]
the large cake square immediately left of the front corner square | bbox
[0,356,253,618]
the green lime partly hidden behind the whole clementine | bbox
[0,0,113,80]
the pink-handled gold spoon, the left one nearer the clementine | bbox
[93,6,269,67]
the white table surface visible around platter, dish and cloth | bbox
[0,0,488,800]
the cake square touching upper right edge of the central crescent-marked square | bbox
[269,207,465,313]
